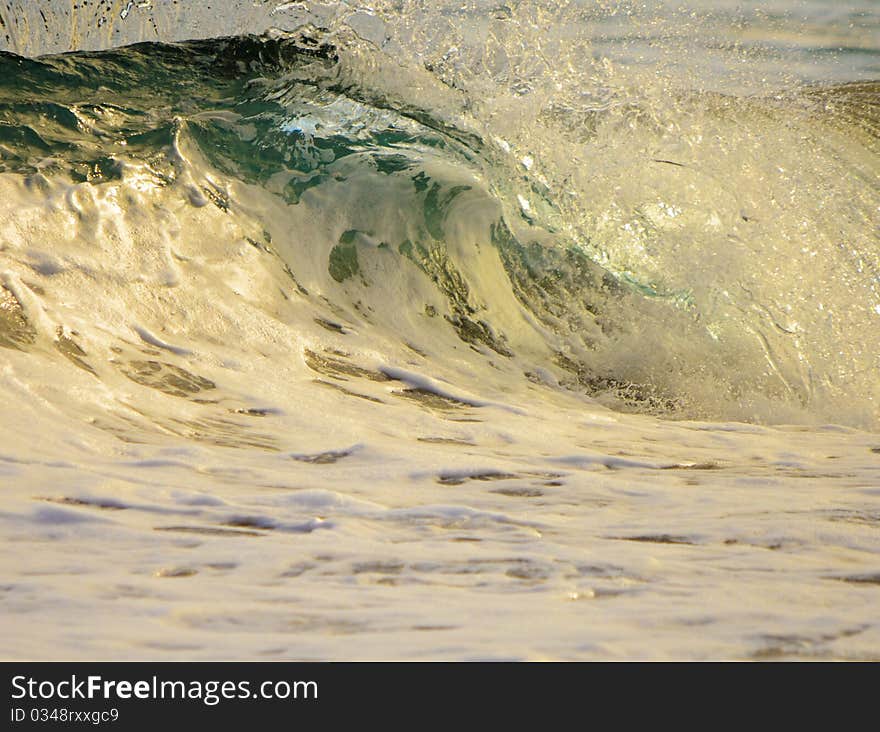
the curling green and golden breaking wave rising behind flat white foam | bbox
[0,20,880,428]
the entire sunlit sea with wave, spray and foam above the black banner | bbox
[0,0,880,660]
